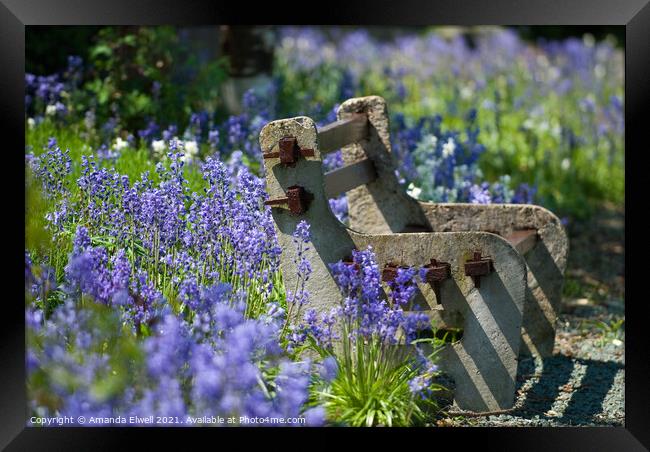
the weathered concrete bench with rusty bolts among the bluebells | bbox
[260,96,567,411]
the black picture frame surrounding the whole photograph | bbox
[0,0,650,451]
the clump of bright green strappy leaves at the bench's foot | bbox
[309,327,444,427]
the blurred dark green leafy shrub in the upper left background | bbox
[53,26,226,131]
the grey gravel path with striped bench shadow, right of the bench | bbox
[436,206,625,427]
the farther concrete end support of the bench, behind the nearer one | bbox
[338,96,568,357]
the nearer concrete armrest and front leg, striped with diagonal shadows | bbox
[350,231,526,411]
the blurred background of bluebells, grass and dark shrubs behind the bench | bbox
[26,26,625,218]
